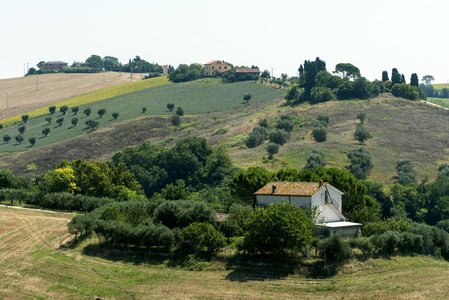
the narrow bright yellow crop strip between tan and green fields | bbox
[2,77,169,126]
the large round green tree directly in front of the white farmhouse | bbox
[239,203,314,256]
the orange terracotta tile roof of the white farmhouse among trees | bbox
[254,181,328,196]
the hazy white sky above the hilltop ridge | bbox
[0,0,449,83]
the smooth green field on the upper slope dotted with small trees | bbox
[0,80,284,152]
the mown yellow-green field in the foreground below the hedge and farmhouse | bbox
[0,207,449,299]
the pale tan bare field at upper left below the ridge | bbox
[0,72,152,122]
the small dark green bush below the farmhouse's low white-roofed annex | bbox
[317,234,352,262]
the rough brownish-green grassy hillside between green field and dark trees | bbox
[0,87,449,183]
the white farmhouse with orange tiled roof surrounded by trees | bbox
[254,181,362,238]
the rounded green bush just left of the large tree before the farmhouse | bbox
[181,223,226,253]
